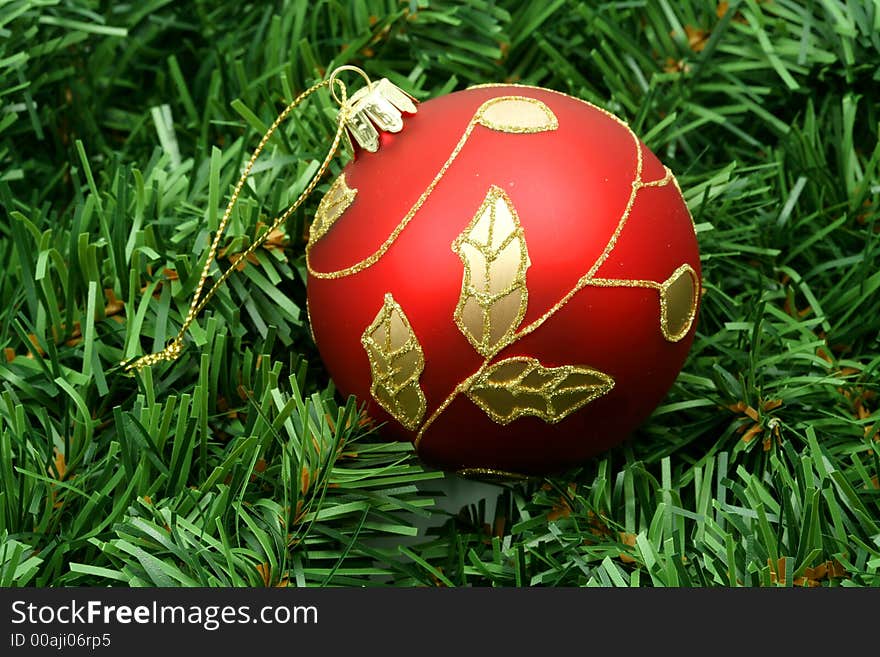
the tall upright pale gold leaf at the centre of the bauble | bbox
[452,185,531,356]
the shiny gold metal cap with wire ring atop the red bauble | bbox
[330,66,418,153]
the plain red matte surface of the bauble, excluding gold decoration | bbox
[308,87,700,473]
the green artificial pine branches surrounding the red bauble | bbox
[0,0,880,586]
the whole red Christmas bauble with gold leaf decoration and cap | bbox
[307,80,700,475]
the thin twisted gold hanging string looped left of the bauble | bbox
[123,71,350,370]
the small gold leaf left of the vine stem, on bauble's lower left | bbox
[361,294,426,430]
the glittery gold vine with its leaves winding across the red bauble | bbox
[306,85,699,449]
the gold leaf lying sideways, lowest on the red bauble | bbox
[466,356,614,424]
